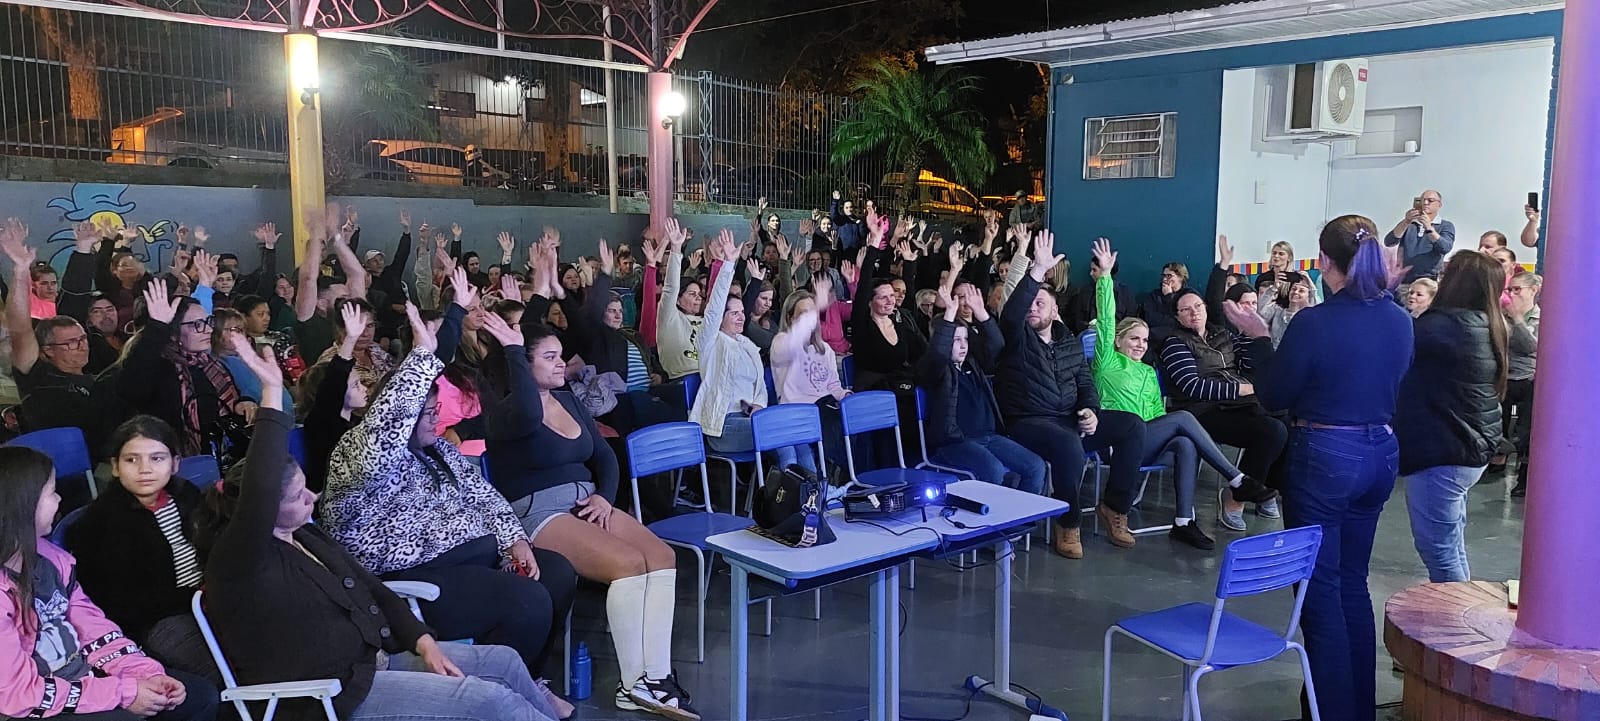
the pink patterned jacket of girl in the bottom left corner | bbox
[0,539,166,718]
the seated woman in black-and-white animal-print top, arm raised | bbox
[320,295,578,718]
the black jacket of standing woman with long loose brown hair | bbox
[1394,309,1501,473]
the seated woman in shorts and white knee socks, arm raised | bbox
[483,315,699,721]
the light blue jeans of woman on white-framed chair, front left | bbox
[355,643,555,721]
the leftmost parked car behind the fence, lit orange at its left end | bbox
[106,107,288,171]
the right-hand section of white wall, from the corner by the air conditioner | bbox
[1328,40,1554,261]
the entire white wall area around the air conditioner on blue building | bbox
[1216,40,1554,262]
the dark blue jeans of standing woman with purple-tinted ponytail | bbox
[1283,425,1400,721]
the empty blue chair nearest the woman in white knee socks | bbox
[627,420,758,663]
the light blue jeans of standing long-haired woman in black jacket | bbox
[1405,465,1486,584]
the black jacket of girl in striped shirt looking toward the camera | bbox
[66,476,200,643]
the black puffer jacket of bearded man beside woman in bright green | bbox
[995,275,1099,427]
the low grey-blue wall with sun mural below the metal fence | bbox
[0,181,761,273]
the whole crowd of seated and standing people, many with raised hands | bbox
[0,190,1539,721]
